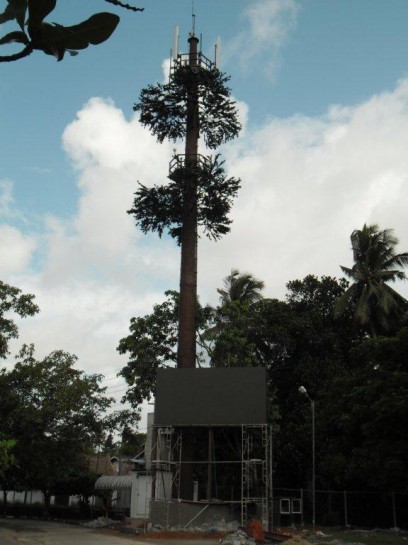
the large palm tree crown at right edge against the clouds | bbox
[334,224,408,337]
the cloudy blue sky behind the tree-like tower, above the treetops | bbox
[0,0,408,422]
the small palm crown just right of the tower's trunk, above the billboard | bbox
[217,269,265,305]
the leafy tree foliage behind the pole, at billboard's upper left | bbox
[118,291,211,406]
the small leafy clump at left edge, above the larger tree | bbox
[0,280,39,358]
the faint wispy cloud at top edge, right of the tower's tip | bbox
[223,0,300,79]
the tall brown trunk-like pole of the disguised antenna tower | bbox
[177,35,200,500]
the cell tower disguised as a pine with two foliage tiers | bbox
[129,27,240,499]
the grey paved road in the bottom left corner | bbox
[0,519,146,545]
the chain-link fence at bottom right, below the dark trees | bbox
[273,488,408,530]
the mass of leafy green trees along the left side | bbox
[0,282,142,502]
